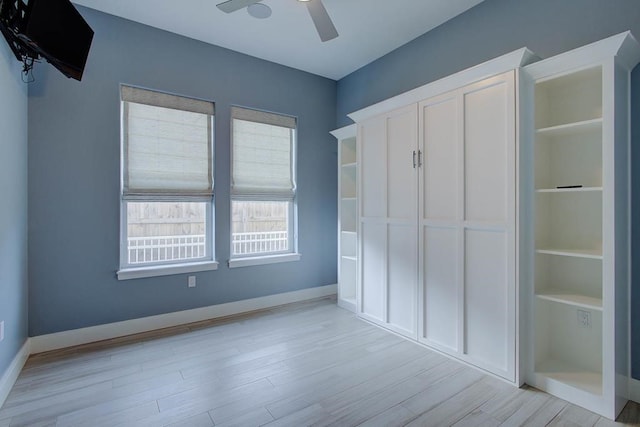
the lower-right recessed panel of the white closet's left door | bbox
[387,224,418,338]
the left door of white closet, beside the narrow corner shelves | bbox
[358,105,418,338]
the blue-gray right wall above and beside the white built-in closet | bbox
[337,0,640,379]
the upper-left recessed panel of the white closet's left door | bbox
[358,118,387,218]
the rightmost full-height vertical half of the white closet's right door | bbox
[463,72,517,381]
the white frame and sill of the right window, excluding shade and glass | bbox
[228,107,301,268]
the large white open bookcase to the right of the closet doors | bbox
[522,33,640,418]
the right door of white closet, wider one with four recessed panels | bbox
[419,71,516,382]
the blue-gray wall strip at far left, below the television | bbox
[0,39,28,377]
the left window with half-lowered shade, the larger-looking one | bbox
[118,86,215,279]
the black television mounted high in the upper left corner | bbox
[0,0,93,80]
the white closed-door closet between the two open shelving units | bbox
[353,50,530,383]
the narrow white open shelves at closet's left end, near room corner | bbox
[332,125,358,312]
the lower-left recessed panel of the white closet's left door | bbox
[360,223,387,322]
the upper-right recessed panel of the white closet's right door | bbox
[464,81,514,222]
